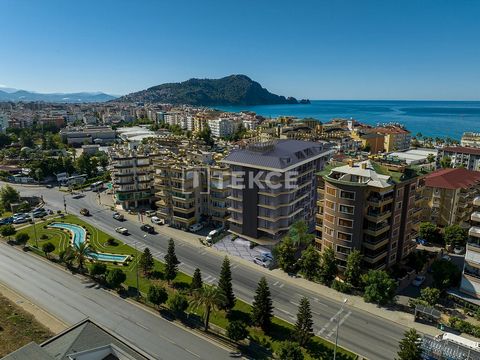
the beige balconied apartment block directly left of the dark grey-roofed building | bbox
[154,150,230,229]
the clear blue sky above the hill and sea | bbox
[0,0,480,100]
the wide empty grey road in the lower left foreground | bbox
[0,242,229,360]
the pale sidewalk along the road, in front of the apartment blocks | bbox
[102,196,443,336]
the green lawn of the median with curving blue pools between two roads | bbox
[18,215,356,360]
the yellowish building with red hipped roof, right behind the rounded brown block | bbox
[423,168,480,227]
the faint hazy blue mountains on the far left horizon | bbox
[0,88,115,103]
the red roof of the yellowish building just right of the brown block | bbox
[425,168,480,189]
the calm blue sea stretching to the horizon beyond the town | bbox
[215,100,480,140]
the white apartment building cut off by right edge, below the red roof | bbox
[460,196,480,298]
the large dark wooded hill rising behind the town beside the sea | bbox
[113,75,308,106]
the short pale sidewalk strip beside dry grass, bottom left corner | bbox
[0,283,67,334]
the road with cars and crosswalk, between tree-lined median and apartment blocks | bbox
[9,186,406,360]
